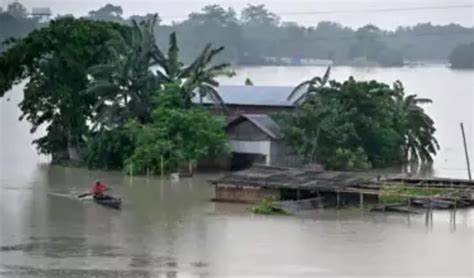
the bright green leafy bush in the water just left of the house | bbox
[125,85,229,173]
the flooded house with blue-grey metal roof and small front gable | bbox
[197,86,300,170]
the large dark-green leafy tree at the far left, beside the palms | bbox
[0,18,128,162]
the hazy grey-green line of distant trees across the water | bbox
[0,4,474,67]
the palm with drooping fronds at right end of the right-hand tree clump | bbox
[394,81,439,163]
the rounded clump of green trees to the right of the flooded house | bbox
[275,77,439,170]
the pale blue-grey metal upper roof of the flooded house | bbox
[195,86,293,107]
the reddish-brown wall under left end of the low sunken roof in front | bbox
[215,185,280,203]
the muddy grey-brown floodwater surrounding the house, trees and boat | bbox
[0,67,474,278]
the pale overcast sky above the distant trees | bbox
[0,0,474,29]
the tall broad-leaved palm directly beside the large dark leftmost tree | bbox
[87,16,160,125]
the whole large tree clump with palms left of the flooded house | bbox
[0,17,233,173]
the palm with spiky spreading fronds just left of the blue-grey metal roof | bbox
[153,32,235,106]
